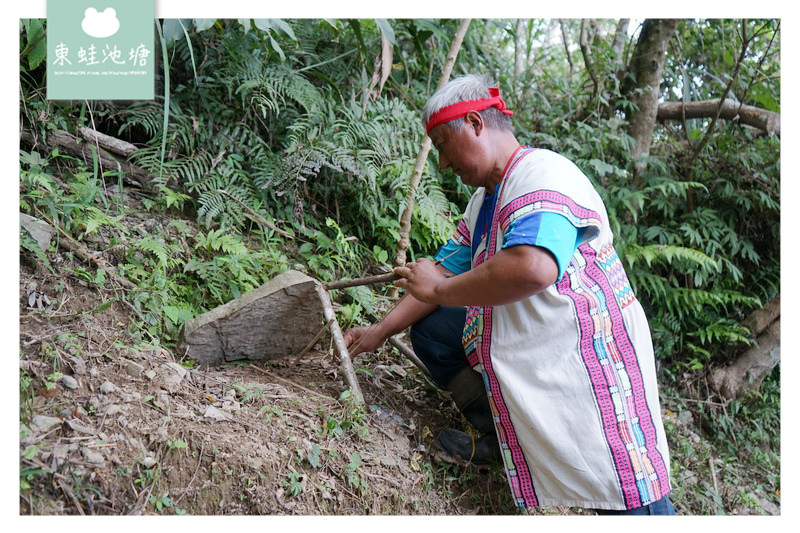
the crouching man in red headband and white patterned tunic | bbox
[345,75,674,514]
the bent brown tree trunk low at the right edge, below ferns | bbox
[709,297,781,400]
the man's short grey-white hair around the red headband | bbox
[422,74,512,131]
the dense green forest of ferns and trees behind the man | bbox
[12,4,781,514]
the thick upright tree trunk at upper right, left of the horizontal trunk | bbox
[625,19,679,184]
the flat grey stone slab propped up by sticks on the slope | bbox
[178,270,324,365]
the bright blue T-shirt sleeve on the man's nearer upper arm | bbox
[503,212,584,280]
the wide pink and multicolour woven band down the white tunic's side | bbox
[556,244,670,509]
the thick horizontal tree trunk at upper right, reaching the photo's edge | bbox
[656,98,781,136]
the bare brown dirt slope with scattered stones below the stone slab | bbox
[19,193,576,515]
